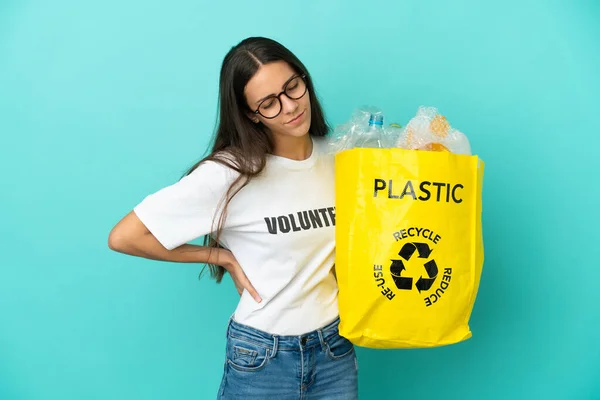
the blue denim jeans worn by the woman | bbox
[217,319,358,400]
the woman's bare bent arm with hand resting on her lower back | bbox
[108,211,261,302]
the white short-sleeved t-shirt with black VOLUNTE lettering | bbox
[134,138,338,335]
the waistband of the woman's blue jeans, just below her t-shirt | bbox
[227,317,340,350]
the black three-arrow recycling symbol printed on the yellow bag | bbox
[390,243,438,293]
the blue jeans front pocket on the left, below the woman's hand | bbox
[227,336,271,372]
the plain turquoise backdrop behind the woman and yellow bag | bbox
[0,0,600,400]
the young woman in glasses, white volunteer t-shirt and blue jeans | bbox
[109,38,357,400]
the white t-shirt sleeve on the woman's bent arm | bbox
[133,161,235,250]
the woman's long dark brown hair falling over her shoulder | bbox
[186,37,329,282]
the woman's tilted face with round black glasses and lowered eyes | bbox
[245,61,311,141]
